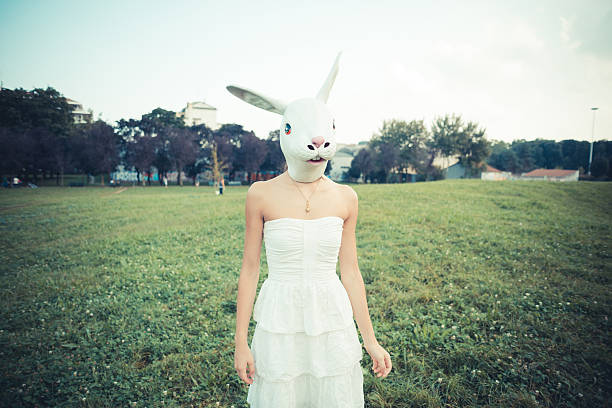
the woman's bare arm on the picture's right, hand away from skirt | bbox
[338,186,391,377]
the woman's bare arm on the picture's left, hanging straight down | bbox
[234,182,263,384]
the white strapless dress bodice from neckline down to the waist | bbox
[264,216,344,283]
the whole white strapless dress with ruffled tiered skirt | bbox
[247,216,364,408]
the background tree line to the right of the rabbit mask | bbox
[348,115,612,183]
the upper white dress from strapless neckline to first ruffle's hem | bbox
[253,216,353,335]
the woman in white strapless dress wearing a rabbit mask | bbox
[227,55,391,408]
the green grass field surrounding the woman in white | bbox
[0,180,612,408]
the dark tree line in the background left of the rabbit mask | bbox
[0,87,285,185]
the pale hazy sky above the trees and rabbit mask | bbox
[0,0,612,143]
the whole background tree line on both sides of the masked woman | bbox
[0,87,612,185]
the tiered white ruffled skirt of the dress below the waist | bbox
[247,274,364,408]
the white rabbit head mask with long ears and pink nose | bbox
[227,54,340,183]
